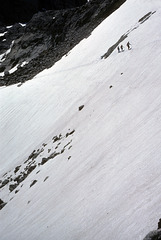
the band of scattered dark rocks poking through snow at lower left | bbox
[0,128,75,210]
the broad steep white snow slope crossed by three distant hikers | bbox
[0,0,161,240]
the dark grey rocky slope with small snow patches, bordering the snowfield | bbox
[0,0,126,86]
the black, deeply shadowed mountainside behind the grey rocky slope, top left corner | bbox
[0,0,86,24]
